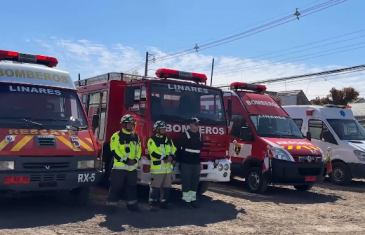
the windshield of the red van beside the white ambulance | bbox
[250,114,304,139]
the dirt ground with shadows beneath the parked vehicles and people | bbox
[0,178,365,235]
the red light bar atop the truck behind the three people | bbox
[156,69,208,83]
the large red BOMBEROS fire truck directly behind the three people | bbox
[75,69,231,193]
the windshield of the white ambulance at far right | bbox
[327,119,365,140]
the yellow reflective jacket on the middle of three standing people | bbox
[147,135,176,174]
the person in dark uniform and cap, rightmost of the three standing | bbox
[177,117,203,208]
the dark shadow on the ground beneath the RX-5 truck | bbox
[0,187,105,230]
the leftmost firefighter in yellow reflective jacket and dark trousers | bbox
[107,114,141,213]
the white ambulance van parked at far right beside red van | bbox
[283,105,365,185]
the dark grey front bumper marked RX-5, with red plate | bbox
[0,156,103,192]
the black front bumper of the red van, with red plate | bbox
[269,159,326,185]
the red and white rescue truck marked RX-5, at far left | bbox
[0,50,102,203]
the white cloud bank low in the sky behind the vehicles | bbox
[36,37,365,99]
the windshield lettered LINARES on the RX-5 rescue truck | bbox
[0,84,88,129]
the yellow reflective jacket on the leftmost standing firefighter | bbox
[110,129,142,171]
